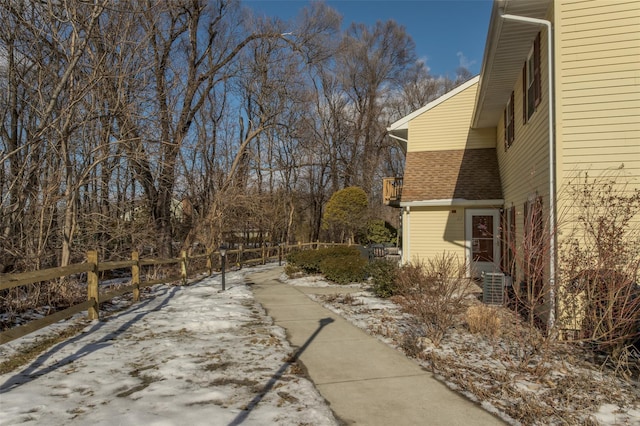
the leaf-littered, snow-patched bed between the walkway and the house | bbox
[281,276,640,425]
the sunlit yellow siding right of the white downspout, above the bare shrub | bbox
[556,0,640,184]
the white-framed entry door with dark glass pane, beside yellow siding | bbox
[465,209,500,277]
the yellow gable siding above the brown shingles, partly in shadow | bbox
[407,83,495,152]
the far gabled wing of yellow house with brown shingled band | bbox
[389,77,504,272]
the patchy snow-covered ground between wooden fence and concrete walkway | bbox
[0,268,337,426]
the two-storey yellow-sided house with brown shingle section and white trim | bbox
[383,0,640,326]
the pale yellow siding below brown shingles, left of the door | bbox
[403,207,465,262]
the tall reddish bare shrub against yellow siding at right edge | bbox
[560,173,640,369]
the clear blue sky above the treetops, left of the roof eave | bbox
[243,0,492,77]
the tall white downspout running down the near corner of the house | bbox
[500,14,556,331]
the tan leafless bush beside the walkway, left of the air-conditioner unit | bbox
[396,253,472,346]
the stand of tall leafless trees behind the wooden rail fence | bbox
[0,0,470,270]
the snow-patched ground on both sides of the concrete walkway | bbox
[0,266,640,425]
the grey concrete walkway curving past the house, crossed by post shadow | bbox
[247,268,503,426]
